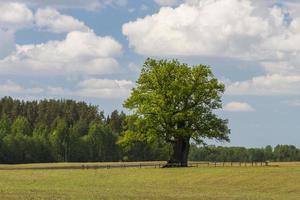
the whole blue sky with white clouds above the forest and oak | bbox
[0,0,300,147]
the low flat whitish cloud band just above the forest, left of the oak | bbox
[0,78,134,99]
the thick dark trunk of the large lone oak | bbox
[164,137,190,167]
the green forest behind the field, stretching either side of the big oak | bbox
[0,97,300,164]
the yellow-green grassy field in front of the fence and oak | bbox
[0,163,300,200]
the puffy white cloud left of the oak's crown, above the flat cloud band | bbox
[0,31,122,76]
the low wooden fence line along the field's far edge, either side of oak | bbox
[0,161,269,170]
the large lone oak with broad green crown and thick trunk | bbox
[124,59,230,166]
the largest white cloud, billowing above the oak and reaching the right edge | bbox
[123,0,300,60]
